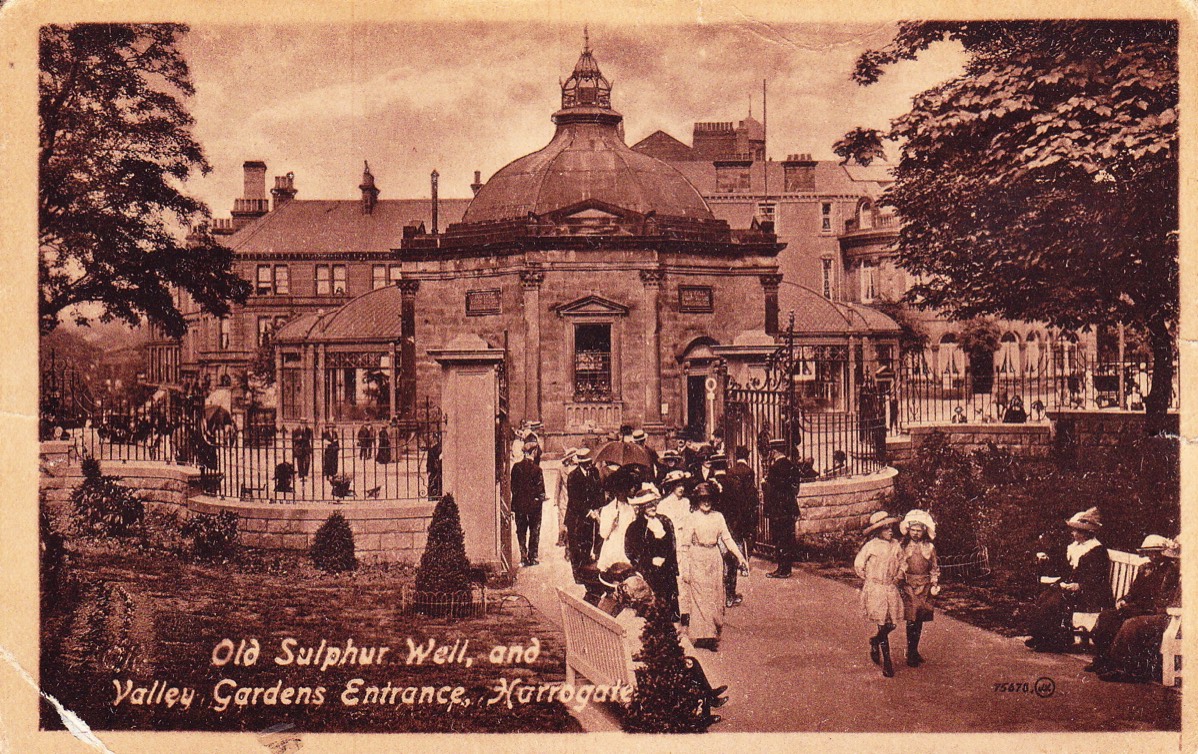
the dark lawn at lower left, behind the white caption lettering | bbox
[42,532,580,732]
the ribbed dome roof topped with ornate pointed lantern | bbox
[462,48,713,223]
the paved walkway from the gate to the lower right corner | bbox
[516,468,1180,732]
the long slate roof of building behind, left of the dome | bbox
[226,199,470,254]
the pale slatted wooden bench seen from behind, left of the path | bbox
[557,589,636,688]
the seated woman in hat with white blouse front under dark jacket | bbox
[1023,508,1114,652]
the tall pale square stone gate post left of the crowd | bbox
[429,334,512,568]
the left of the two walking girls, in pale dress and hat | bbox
[853,511,907,678]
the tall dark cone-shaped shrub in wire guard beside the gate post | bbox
[416,495,471,615]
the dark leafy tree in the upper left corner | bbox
[38,24,250,337]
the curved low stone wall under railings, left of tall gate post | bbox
[187,496,436,563]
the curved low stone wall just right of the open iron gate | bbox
[794,466,899,535]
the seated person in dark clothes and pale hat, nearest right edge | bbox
[1085,535,1181,674]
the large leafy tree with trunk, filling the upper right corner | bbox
[837,20,1179,432]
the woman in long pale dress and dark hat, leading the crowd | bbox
[685,482,749,652]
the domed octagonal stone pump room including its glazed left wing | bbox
[276,39,785,451]
